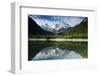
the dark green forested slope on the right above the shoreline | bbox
[63,18,88,38]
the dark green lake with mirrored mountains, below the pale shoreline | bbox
[28,41,88,61]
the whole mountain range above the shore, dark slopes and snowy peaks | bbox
[28,17,88,36]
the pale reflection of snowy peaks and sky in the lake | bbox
[32,46,82,60]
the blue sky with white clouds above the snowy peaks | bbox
[30,15,84,27]
